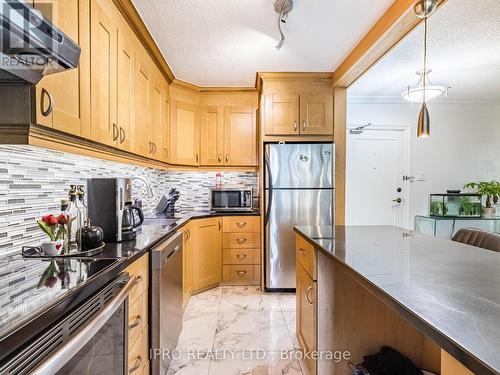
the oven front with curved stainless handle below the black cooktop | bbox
[0,273,136,375]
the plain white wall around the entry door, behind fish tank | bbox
[347,99,500,228]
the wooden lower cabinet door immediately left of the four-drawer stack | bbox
[192,218,222,291]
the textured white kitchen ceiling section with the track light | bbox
[133,0,392,86]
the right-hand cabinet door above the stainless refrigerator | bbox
[300,95,333,135]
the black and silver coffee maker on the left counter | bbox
[87,178,144,242]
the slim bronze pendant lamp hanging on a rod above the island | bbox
[413,0,438,138]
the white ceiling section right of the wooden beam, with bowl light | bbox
[349,0,500,103]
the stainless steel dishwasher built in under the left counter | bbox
[150,233,183,375]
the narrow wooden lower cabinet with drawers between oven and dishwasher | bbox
[126,254,149,374]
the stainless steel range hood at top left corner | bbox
[0,0,80,84]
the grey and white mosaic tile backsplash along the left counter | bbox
[0,145,258,256]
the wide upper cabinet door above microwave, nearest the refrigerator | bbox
[224,107,257,166]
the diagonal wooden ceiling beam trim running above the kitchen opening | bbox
[332,0,446,87]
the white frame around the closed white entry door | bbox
[346,125,411,229]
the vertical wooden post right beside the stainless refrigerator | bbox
[333,88,347,225]
